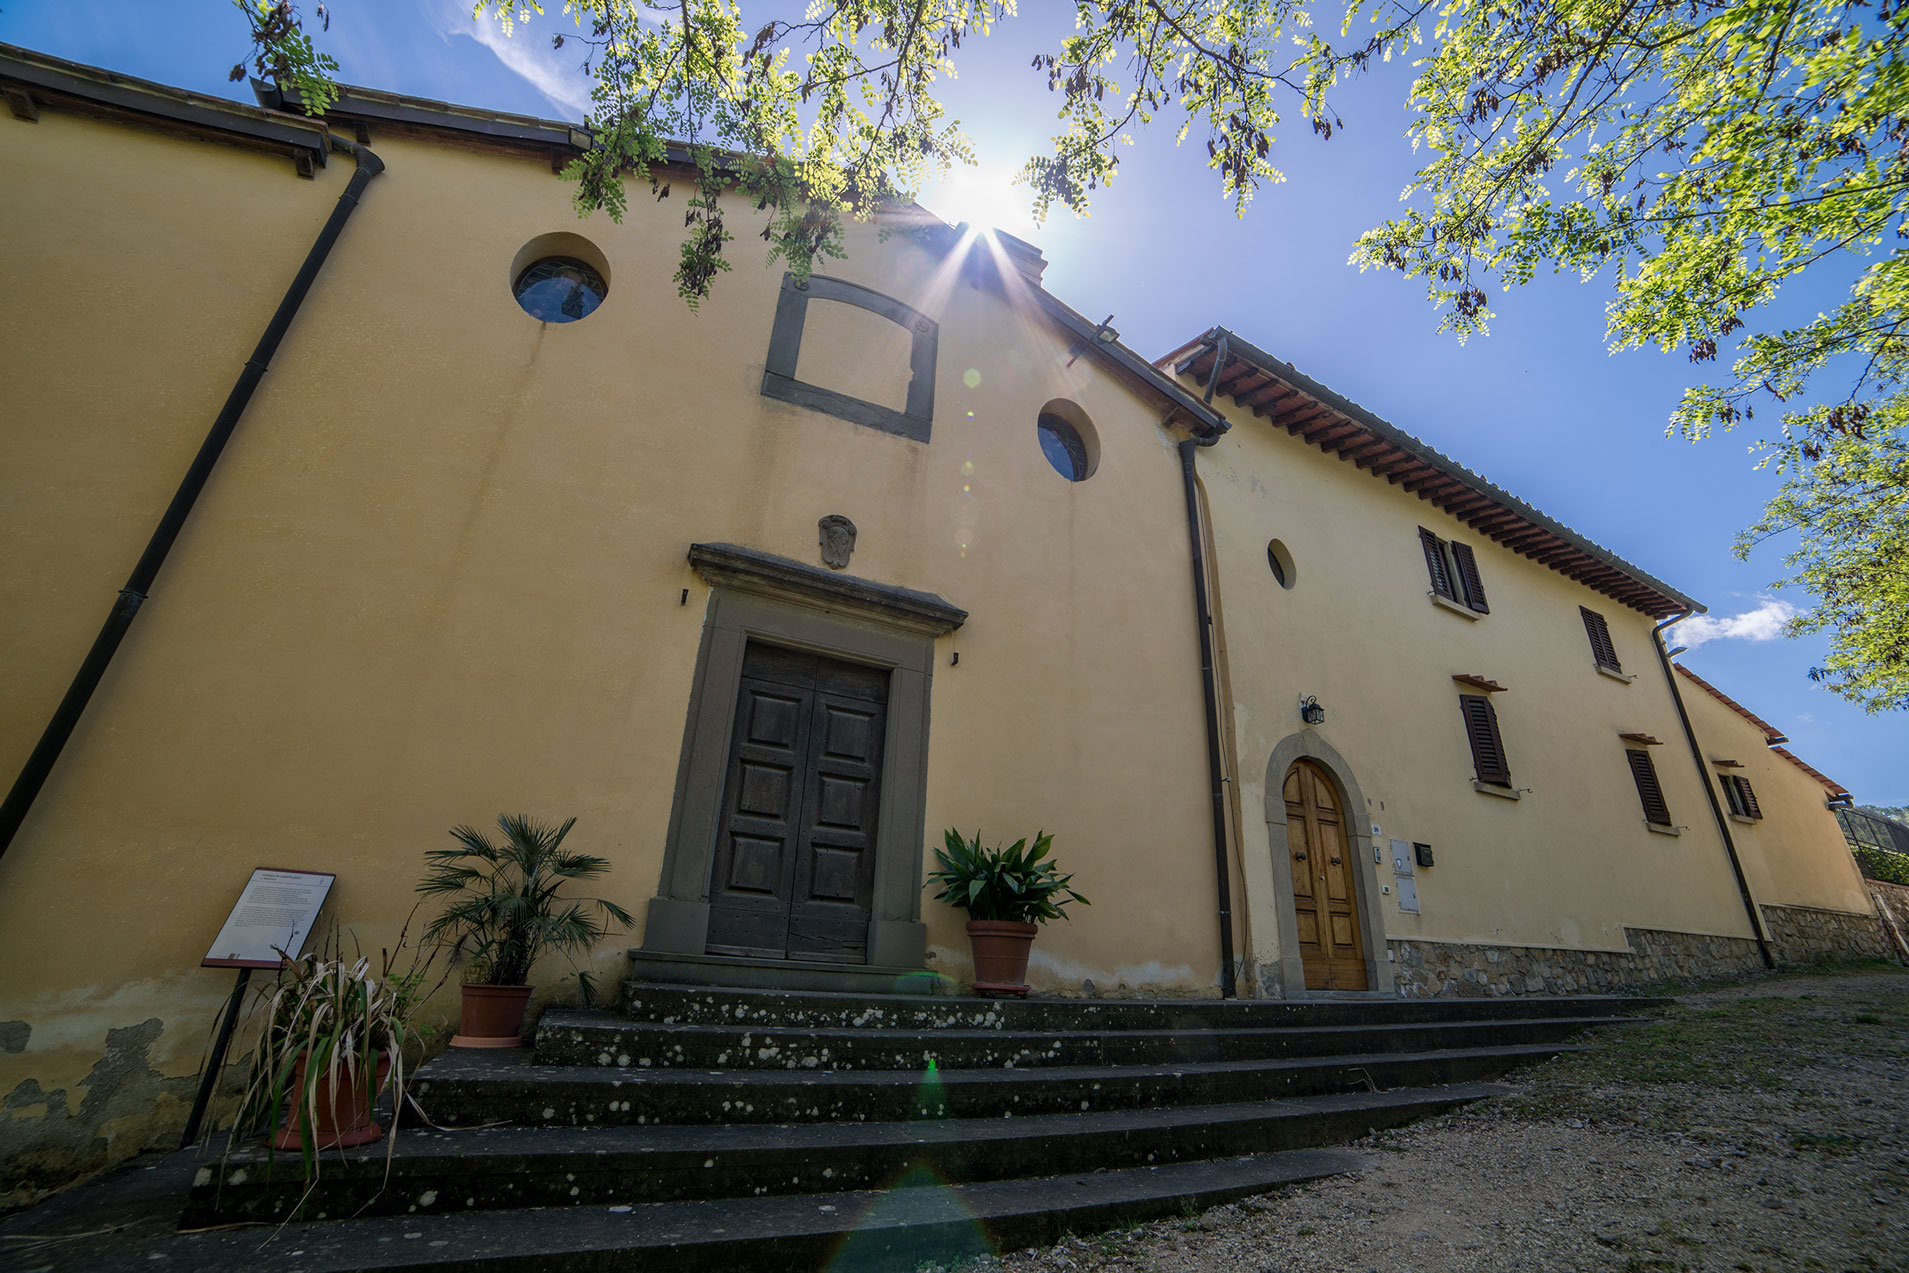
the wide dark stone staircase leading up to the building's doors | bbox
[183,983,1653,1273]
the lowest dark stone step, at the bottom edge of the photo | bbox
[164,1149,1367,1273]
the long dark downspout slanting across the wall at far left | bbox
[0,137,384,855]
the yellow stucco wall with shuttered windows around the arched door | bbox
[1199,403,1751,970]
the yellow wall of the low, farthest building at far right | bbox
[1678,678,1875,914]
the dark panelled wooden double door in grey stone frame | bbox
[706,641,890,964]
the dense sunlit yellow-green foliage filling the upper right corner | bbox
[1353,0,1909,710]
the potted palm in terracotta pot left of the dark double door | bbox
[418,813,636,1048]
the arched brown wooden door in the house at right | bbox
[1285,760,1367,991]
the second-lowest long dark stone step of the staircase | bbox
[183,1084,1504,1227]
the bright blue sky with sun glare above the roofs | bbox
[0,0,1909,805]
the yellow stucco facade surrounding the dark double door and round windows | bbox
[0,111,1218,1198]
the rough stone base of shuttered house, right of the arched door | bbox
[1386,928,1764,998]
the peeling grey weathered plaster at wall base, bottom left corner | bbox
[0,1017,197,1212]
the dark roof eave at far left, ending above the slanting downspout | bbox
[0,44,330,177]
